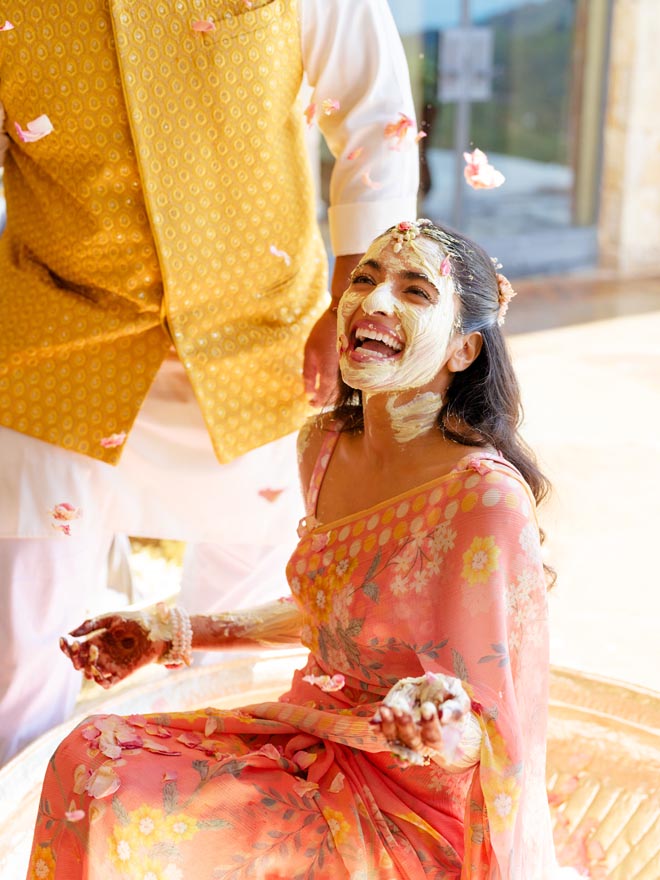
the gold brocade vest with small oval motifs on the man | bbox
[0,0,326,463]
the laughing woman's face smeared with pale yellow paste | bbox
[337,235,456,393]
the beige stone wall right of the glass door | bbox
[599,0,660,275]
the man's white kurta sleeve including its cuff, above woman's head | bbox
[300,0,419,254]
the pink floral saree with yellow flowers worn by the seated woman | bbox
[29,433,555,880]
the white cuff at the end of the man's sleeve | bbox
[328,197,417,257]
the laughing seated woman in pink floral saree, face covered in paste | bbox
[30,220,556,880]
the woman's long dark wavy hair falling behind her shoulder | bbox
[333,221,550,576]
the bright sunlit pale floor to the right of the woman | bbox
[507,276,660,690]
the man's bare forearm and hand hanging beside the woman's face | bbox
[303,254,362,406]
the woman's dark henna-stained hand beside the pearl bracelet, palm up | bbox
[60,614,168,689]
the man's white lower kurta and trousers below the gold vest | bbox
[0,361,303,764]
